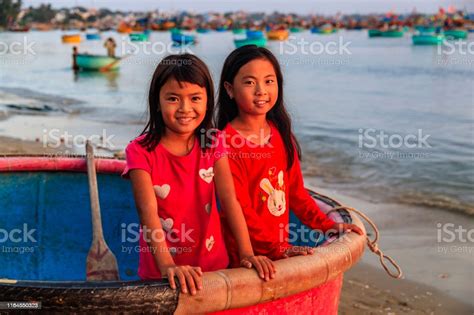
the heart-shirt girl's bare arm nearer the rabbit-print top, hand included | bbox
[214,157,275,280]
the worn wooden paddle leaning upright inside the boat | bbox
[86,141,119,281]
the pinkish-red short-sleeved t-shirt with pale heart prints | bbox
[122,136,229,279]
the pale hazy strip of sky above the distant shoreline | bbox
[23,0,474,14]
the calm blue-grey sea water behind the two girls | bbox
[0,31,474,214]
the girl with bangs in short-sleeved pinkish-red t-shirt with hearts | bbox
[123,54,275,295]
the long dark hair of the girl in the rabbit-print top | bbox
[216,45,301,168]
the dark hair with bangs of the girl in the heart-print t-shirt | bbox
[139,54,214,151]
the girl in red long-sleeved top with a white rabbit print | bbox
[217,45,363,267]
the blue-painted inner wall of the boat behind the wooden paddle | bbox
[0,172,139,281]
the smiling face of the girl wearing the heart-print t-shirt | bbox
[160,79,207,135]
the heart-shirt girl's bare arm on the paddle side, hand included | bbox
[129,169,202,295]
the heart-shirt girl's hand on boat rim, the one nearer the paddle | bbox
[161,265,202,295]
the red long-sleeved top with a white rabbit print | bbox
[221,124,334,267]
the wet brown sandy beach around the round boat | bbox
[0,137,474,314]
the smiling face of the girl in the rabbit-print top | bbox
[224,59,278,115]
